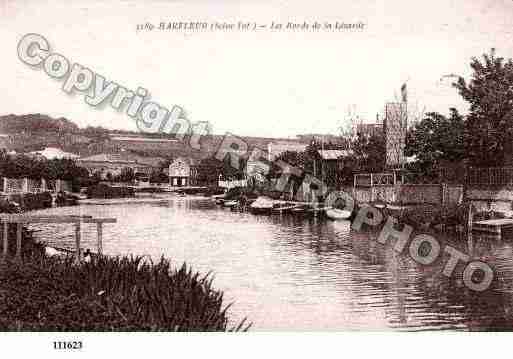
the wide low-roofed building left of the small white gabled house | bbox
[77,152,164,178]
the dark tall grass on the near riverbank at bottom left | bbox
[0,255,250,331]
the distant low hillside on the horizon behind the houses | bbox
[0,114,314,159]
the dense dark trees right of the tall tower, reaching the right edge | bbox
[406,49,513,179]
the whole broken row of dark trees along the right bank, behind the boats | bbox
[197,49,513,188]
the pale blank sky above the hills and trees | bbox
[0,0,513,137]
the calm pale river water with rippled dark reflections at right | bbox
[29,196,513,330]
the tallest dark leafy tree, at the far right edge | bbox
[453,49,513,166]
